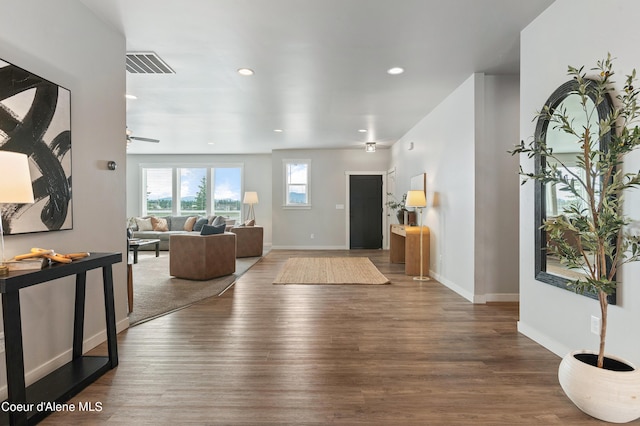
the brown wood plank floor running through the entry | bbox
[41,250,600,426]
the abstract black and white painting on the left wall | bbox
[0,60,73,235]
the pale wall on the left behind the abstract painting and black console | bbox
[0,0,128,395]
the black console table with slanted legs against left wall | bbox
[0,253,122,425]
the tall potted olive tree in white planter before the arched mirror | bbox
[511,55,640,423]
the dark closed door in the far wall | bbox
[349,175,382,249]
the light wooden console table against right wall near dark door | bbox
[389,225,429,275]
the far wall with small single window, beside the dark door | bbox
[271,150,389,249]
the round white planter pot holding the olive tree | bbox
[558,351,640,423]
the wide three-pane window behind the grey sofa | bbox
[141,165,242,216]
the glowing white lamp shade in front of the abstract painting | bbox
[0,151,33,204]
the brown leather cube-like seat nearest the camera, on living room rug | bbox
[169,232,236,280]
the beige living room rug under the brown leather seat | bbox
[129,251,262,326]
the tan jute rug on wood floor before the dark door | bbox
[273,257,389,284]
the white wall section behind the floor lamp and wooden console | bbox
[391,74,518,303]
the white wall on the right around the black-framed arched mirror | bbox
[519,0,640,365]
